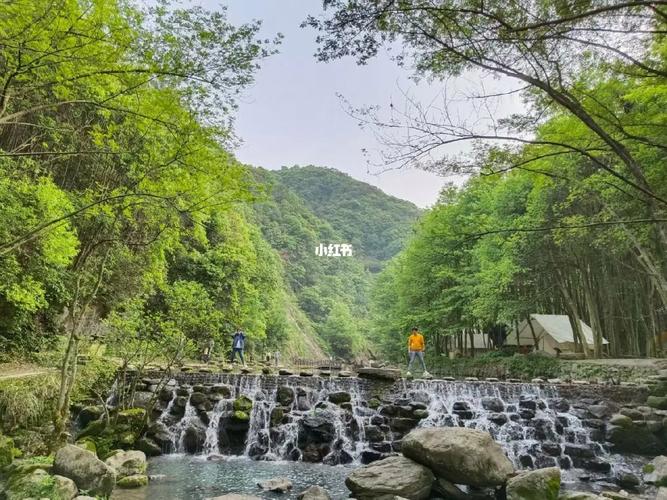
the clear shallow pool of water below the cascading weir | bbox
[112,455,352,500]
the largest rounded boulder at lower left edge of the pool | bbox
[53,444,116,496]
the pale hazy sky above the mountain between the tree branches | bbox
[198,0,520,207]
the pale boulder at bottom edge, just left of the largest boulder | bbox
[345,456,434,500]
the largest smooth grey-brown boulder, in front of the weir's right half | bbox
[401,427,514,487]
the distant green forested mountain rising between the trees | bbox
[253,166,419,359]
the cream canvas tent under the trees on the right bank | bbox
[505,314,609,354]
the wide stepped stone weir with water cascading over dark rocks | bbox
[130,373,662,474]
